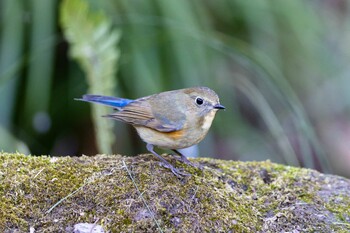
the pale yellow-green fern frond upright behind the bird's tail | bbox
[60,0,120,153]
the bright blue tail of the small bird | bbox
[75,95,133,108]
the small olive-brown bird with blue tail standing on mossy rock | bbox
[76,87,225,177]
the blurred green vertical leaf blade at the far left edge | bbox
[0,0,23,151]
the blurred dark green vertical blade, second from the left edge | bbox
[20,0,56,135]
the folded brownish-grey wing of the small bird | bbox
[107,99,185,132]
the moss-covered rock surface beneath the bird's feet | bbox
[0,153,350,232]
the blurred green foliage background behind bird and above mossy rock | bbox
[0,0,350,177]
